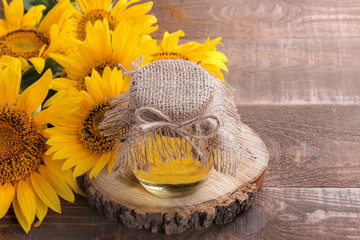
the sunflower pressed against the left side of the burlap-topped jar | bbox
[46,66,130,177]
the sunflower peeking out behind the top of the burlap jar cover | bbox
[151,30,228,80]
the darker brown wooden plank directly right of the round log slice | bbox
[238,104,360,188]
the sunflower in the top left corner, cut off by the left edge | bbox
[0,0,81,73]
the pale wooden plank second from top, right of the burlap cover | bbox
[219,38,360,104]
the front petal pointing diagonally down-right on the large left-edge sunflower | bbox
[31,173,61,213]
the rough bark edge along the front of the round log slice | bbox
[78,175,258,234]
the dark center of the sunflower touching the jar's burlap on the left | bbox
[80,101,116,153]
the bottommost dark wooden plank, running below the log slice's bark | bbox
[0,187,360,240]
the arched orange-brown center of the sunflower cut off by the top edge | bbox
[76,9,118,41]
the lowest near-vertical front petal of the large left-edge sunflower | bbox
[16,180,36,227]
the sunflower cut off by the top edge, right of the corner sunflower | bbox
[71,0,157,40]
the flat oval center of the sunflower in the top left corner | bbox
[0,29,50,59]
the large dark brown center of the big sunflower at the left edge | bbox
[0,107,46,185]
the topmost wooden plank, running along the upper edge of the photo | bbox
[152,0,360,41]
